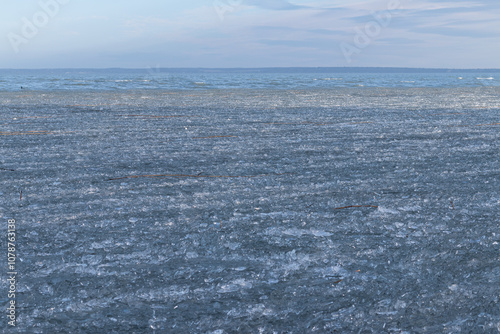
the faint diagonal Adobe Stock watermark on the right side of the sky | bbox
[340,0,401,64]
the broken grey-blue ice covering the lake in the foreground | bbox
[0,87,500,334]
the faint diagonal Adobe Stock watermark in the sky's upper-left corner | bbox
[7,0,71,53]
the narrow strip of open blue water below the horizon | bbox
[0,68,500,91]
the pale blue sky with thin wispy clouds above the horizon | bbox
[0,0,500,68]
